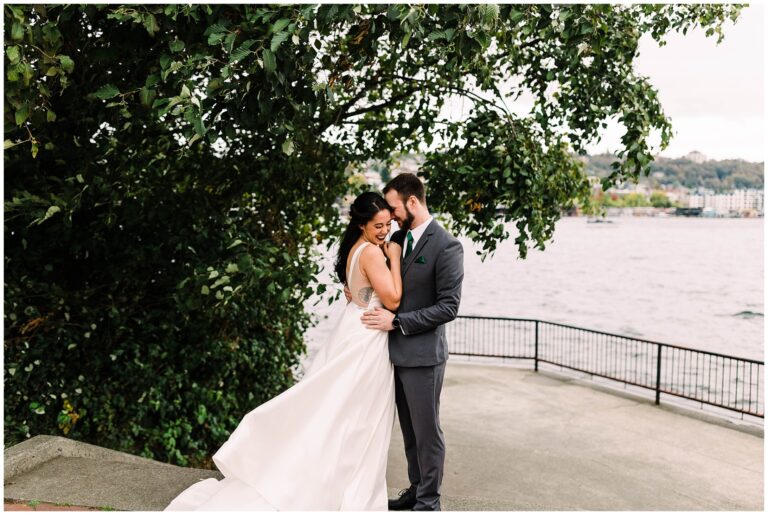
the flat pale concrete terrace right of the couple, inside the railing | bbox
[387,360,764,511]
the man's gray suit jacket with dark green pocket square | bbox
[389,219,464,367]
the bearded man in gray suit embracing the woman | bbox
[362,173,464,511]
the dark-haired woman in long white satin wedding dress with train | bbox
[165,192,402,511]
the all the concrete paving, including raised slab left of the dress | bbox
[5,360,764,511]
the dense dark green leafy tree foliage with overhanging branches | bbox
[3,4,738,464]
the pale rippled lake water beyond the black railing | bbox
[307,217,764,360]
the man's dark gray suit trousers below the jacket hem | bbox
[395,362,445,510]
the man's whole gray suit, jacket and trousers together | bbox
[389,220,464,510]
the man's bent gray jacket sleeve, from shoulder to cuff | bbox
[398,239,464,336]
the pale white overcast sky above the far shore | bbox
[590,5,765,162]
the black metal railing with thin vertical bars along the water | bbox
[447,316,765,418]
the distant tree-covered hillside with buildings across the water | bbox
[583,154,763,192]
